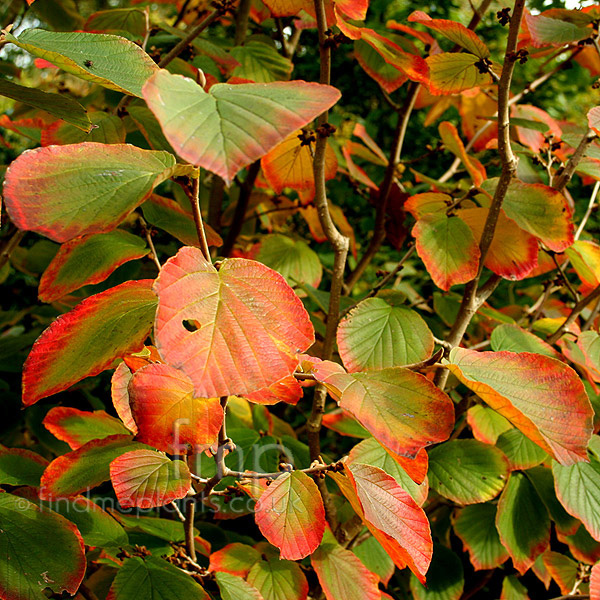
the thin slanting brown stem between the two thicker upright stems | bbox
[345,81,420,293]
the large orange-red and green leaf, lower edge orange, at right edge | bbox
[448,348,593,465]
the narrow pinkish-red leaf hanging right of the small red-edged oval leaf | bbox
[345,463,433,581]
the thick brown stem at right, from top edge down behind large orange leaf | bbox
[434,0,525,389]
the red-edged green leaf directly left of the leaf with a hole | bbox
[23,279,156,406]
